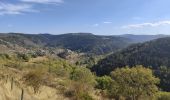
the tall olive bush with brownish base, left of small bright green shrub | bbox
[66,67,96,100]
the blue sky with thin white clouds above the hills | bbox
[0,0,170,35]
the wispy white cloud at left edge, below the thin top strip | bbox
[0,2,37,15]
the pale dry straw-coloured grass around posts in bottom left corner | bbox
[0,68,68,100]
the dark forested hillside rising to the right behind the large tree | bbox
[92,37,170,75]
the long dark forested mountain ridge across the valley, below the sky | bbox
[0,33,131,54]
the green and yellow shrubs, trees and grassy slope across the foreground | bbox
[0,54,170,100]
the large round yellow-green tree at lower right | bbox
[111,66,159,100]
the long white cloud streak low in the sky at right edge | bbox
[122,20,170,28]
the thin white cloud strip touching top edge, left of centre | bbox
[20,0,64,4]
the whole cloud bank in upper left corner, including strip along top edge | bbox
[0,0,64,15]
